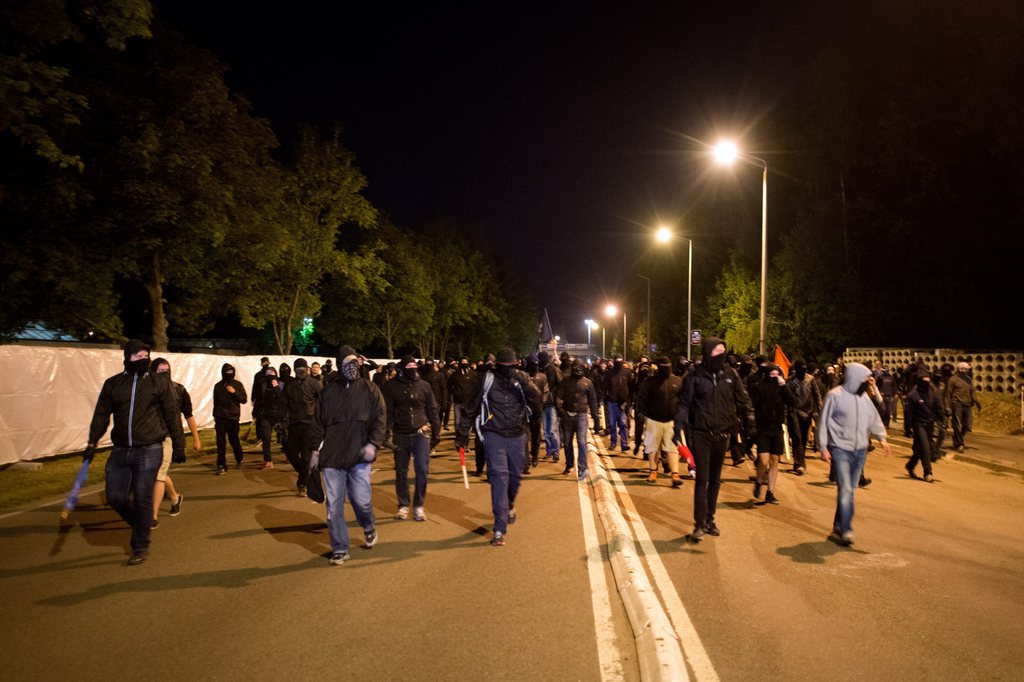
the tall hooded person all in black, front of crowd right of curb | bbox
[676,337,757,542]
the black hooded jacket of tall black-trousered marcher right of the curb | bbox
[676,337,757,435]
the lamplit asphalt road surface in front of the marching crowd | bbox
[0,425,1024,680]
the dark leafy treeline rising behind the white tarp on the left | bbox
[0,0,537,356]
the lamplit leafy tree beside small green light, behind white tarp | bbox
[236,127,382,354]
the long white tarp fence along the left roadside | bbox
[0,345,344,464]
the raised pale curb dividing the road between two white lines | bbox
[590,450,689,682]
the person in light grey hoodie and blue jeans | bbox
[817,363,890,547]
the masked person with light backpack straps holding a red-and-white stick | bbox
[456,348,541,547]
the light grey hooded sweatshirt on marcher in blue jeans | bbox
[818,363,886,452]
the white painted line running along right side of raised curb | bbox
[597,441,718,682]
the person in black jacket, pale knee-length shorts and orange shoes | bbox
[637,355,683,487]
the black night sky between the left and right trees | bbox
[157,0,1019,341]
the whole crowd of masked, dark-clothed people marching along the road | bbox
[83,338,980,565]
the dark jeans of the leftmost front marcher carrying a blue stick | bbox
[106,442,164,554]
